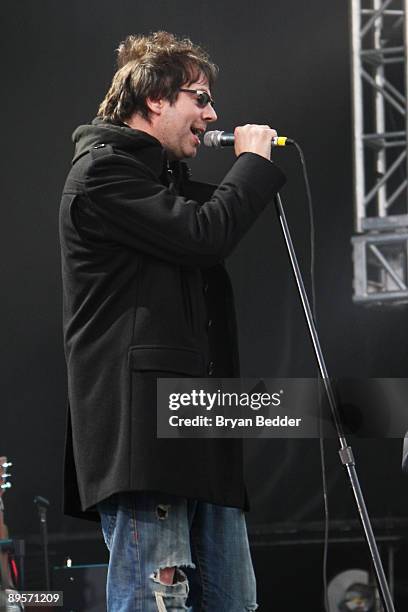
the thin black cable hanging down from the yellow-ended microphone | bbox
[290,139,330,612]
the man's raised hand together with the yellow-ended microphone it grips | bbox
[204,124,293,159]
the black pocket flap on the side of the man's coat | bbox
[129,346,204,377]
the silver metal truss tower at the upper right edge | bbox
[350,0,408,303]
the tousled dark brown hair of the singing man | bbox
[98,32,218,123]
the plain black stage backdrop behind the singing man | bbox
[0,0,408,608]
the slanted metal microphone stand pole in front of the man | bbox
[275,194,395,612]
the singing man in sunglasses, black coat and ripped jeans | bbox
[60,32,284,612]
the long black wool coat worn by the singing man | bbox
[60,119,284,518]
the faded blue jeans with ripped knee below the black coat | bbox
[98,492,257,612]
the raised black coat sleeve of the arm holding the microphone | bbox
[82,152,285,266]
